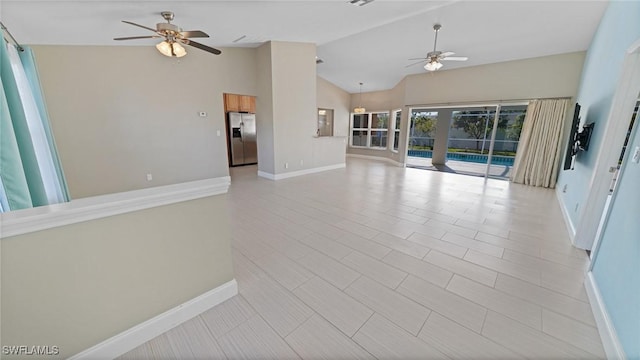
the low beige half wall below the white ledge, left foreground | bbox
[1,195,233,358]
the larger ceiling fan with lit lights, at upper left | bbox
[113,11,222,57]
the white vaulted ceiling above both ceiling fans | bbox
[0,0,608,93]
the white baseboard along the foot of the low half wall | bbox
[69,279,238,360]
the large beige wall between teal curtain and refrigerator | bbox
[34,46,257,198]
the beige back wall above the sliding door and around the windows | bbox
[347,52,585,163]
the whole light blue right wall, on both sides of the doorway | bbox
[558,1,640,359]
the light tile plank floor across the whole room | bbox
[122,159,605,359]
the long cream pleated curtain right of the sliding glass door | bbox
[511,99,569,188]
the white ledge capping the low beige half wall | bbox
[0,176,231,238]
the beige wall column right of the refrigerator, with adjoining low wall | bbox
[258,41,340,177]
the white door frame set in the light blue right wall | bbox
[574,39,640,250]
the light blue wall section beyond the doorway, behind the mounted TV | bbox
[557,1,640,228]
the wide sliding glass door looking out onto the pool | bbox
[407,104,527,179]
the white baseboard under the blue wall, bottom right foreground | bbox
[584,271,627,360]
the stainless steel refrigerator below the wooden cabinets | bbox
[227,112,258,166]
